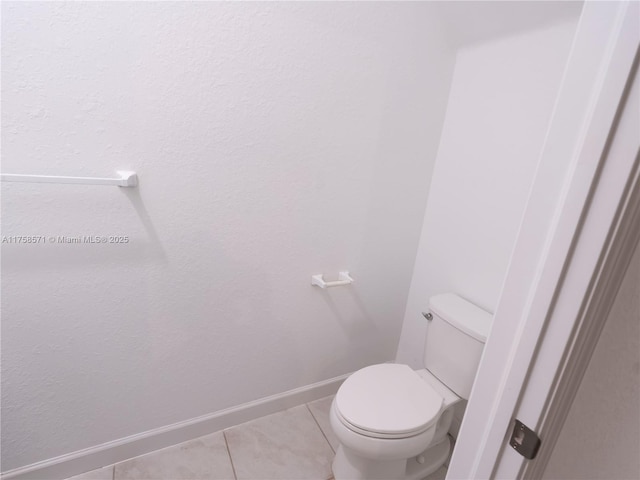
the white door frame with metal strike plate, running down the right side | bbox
[447,2,640,479]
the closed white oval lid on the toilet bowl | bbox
[335,363,442,436]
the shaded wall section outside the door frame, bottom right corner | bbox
[544,242,640,480]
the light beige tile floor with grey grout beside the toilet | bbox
[68,397,446,480]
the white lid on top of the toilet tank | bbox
[429,293,493,343]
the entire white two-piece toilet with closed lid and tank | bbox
[330,293,492,480]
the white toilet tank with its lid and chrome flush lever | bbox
[424,293,493,399]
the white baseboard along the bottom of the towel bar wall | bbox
[0,375,348,480]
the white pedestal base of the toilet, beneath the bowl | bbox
[332,436,451,480]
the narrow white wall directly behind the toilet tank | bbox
[396,18,578,368]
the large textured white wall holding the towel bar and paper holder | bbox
[2,2,458,471]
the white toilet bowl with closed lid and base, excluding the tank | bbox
[330,364,460,480]
